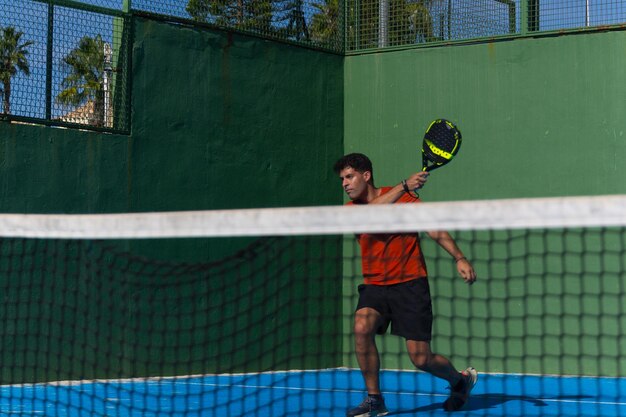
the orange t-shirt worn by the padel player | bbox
[348,187,428,285]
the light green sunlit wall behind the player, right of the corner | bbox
[344,31,626,376]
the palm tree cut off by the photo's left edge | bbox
[0,26,33,115]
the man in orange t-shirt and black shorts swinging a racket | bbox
[334,153,478,417]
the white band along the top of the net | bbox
[0,195,626,239]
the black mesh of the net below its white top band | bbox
[0,216,626,416]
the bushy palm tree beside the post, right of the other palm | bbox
[57,35,107,127]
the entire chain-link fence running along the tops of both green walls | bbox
[0,0,626,131]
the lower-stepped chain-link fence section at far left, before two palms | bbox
[0,0,129,131]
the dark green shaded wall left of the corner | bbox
[0,16,343,383]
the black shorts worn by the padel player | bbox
[356,278,433,342]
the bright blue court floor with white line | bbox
[0,369,626,417]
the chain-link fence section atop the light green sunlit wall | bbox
[345,0,626,51]
